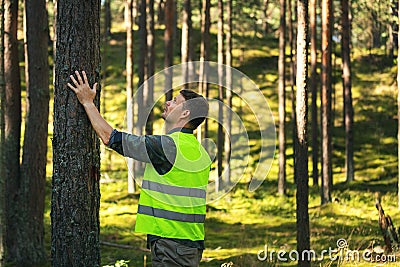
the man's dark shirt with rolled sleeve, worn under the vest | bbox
[108,128,204,249]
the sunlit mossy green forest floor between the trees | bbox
[38,28,400,267]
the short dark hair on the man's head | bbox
[180,89,208,130]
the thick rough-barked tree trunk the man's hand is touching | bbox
[51,0,100,267]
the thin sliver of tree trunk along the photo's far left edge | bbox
[0,0,6,267]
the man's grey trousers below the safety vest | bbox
[151,238,203,267]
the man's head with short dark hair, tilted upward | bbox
[162,89,208,130]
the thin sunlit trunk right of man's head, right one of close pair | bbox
[223,0,233,186]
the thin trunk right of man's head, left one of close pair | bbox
[215,0,224,192]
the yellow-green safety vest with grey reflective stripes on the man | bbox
[135,132,211,241]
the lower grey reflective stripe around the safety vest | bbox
[138,205,206,223]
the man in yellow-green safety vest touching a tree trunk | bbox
[68,71,211,267]
